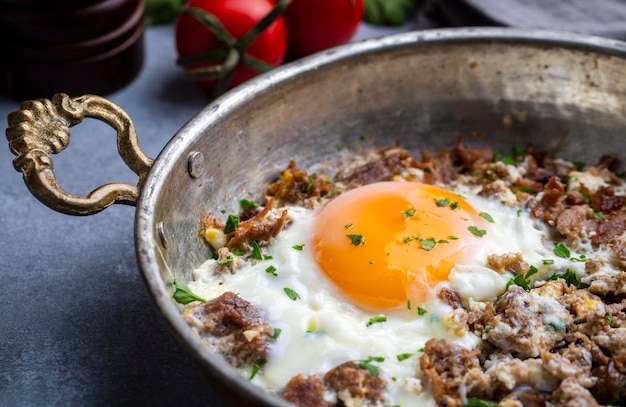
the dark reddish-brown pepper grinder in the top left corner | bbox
[0,0,144,100]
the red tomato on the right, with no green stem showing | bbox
[285,0,363,57]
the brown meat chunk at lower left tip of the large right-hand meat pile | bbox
[420,339,480,407]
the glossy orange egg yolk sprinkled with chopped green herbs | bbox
[312,182,486,310]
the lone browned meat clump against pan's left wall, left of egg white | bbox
[183,292,274,367]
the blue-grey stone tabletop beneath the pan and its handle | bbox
[0,21,407,407]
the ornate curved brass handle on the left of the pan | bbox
[6,93,153,215]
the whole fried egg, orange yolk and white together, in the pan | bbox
[189,182,565,405]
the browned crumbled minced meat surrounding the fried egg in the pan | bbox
[186,139,626,407]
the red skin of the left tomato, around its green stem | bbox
[175,0,287,92]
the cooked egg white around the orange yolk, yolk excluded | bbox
[189,186,576,406]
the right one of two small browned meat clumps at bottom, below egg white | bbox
[324,361,386,406]
